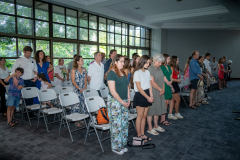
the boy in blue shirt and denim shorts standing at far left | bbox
[4,67,25,127]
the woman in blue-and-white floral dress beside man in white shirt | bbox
[71,56,87,127]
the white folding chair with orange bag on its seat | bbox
[84,96,110,152]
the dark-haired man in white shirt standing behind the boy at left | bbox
[12,46,38,106]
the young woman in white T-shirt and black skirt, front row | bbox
[133,55,153,141]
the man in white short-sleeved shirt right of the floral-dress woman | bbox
[88,52,104,96]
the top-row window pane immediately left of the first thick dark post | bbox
[35,1,49,21]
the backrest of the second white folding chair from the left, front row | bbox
[37,89,57,102]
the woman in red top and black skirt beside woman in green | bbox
[168,56,183,120]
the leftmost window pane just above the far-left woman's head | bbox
[0,37,17,57]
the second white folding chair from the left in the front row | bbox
[37,89,62,133]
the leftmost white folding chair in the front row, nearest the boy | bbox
[21,87,46,126]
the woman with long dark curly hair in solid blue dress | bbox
[33,50,53,104]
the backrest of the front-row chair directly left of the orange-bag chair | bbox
[59,92,80,107]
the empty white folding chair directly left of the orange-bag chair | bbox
[59,92,89,142]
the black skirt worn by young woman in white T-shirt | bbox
[133,89,152,107]
